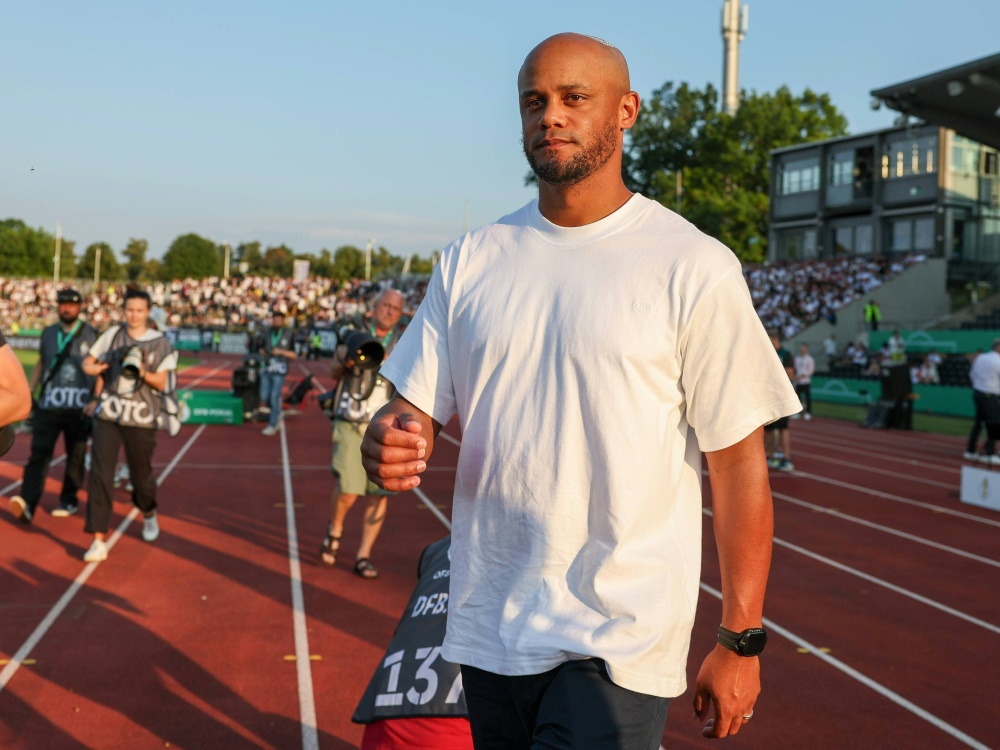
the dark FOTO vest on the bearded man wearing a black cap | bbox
[39,320,97,411]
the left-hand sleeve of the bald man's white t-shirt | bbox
[380,263,457,424]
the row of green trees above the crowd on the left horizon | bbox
[0,225,432,282]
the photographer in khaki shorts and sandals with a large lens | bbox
[320,289,403,578]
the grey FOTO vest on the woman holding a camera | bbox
[97,326,173,430]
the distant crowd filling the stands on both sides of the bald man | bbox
[0,255,925,339]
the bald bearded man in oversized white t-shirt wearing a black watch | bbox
[361,34,801,748]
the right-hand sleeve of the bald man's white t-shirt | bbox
[681,266,802,452]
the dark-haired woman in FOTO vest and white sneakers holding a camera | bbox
[83,289,177,562]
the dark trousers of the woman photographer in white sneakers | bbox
[84,419,156,534]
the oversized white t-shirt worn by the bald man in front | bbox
[382,195,801,697]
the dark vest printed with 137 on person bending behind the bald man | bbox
[351,536,469,724]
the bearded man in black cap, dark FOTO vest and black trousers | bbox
[10,289,97,524]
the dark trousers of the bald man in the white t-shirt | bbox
[462,659,670,750]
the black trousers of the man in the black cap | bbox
[21,409,88,513]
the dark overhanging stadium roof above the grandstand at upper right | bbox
[871,54,1000,149]
